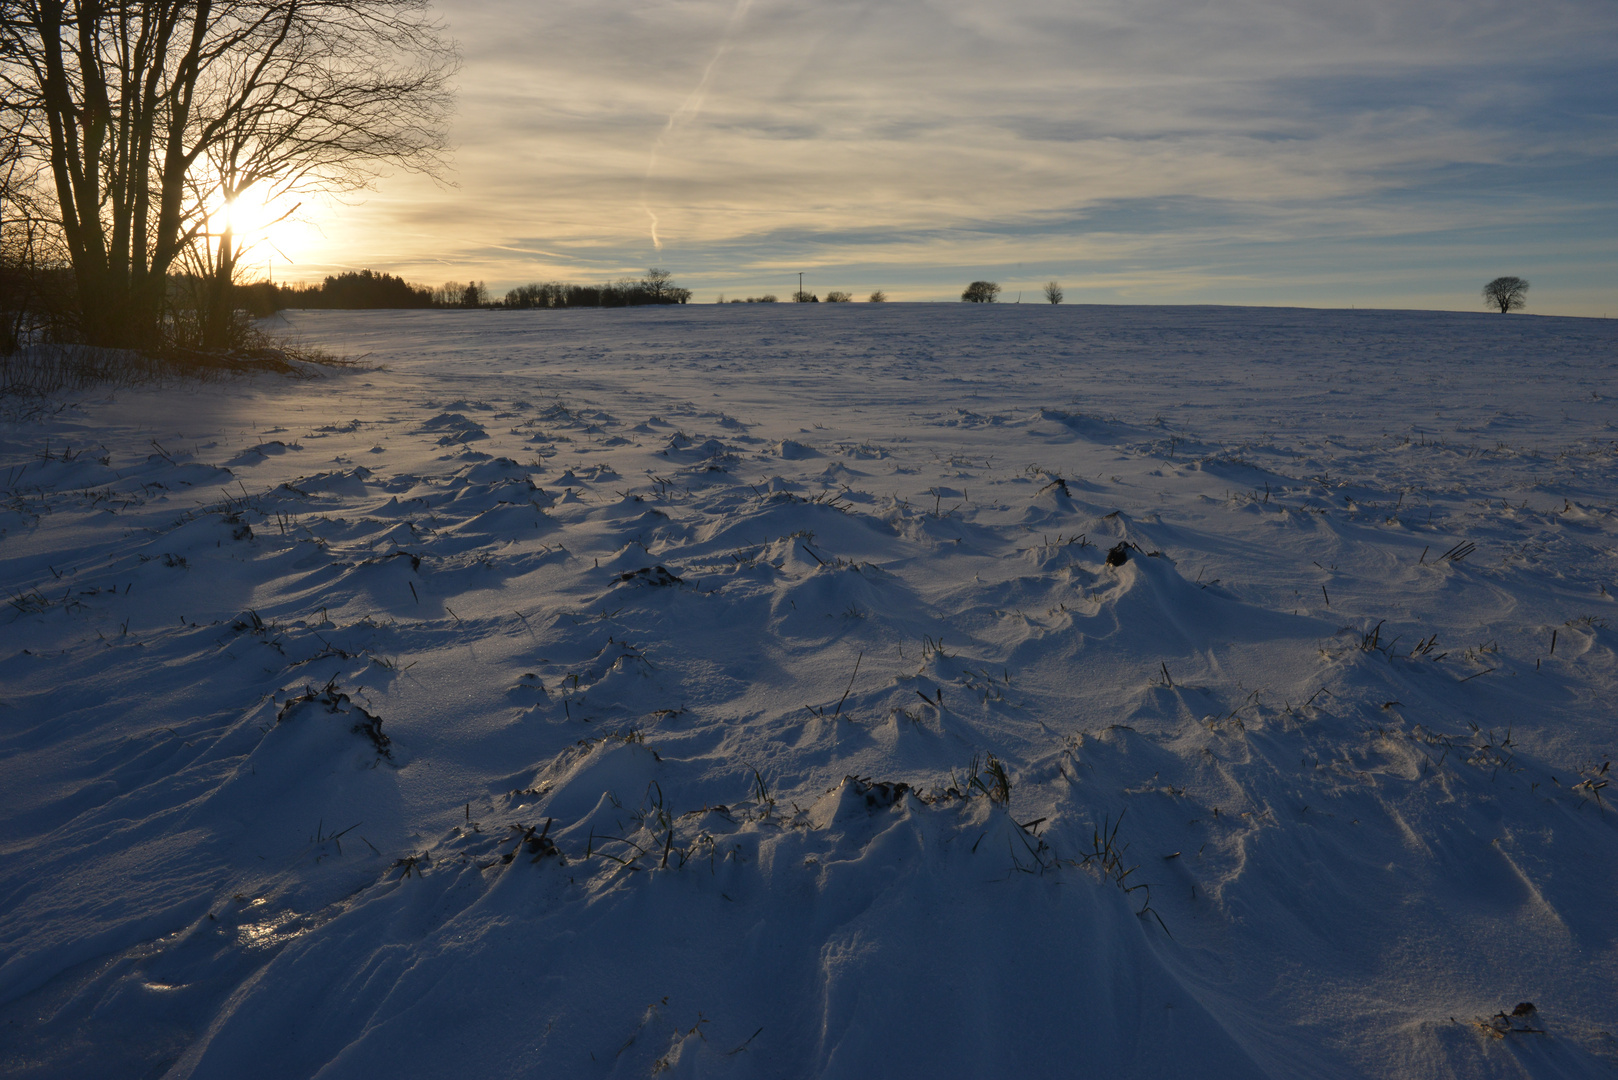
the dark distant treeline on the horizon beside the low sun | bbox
[249,269,691,314]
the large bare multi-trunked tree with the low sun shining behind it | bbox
[0,0,455,347]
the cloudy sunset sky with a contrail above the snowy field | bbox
[256,0,1618,316]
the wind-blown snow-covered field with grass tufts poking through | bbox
[0,304,1618,1078]
